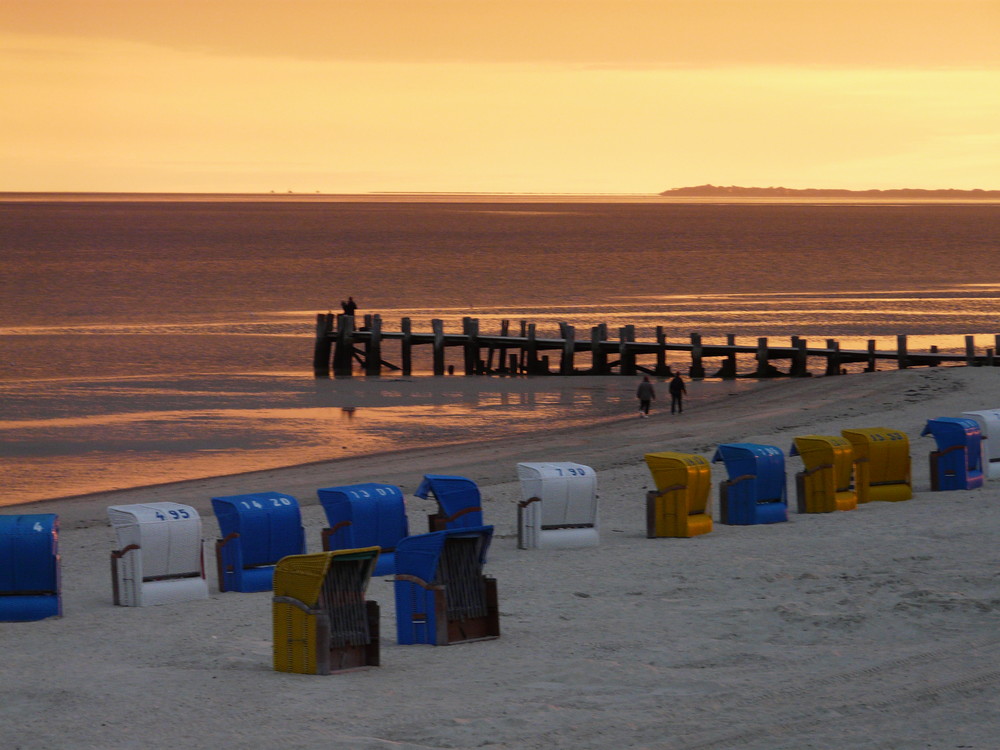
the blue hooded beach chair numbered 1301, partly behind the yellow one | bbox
[317,482,410,575]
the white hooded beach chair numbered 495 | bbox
[108,503,208,607]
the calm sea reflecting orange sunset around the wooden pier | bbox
[0,194,1000,505]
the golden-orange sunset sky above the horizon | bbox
[0,0,1000,193]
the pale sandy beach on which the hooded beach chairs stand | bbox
[0,368,1000,750]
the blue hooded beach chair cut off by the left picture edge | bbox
[0,513,62,622]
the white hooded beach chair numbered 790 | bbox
[517,463,600,549]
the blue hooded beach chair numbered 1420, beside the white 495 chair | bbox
[212,492,306,592]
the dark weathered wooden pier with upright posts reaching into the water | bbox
[313,313,1000,378]
